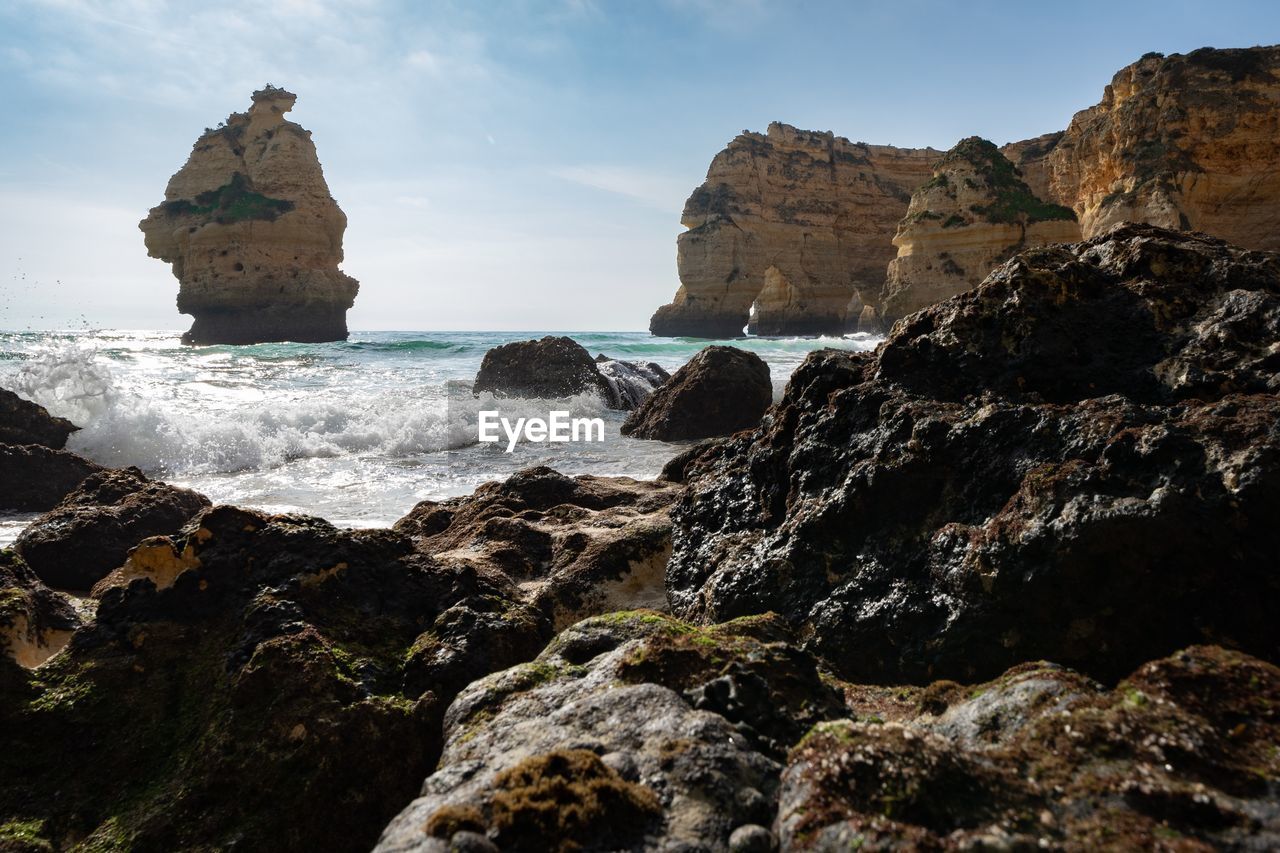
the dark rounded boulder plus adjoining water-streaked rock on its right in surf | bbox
[472,334,668,411]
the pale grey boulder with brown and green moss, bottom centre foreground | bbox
[376,611,845,853]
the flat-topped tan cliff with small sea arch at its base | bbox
[649,123,940,337]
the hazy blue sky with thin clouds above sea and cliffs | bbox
[0,0,1280,330]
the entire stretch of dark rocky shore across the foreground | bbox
[0,225,1280,850]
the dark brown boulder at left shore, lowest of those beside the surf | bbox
[14,467,209,589]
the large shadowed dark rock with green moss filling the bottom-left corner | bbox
[0,507,550,850]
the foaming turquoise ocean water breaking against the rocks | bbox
[0,330,878,544]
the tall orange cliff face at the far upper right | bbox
[1006,46,1280,250]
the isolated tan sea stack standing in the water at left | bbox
[140,87,358,343]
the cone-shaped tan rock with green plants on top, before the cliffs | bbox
[881,136,1080,327]
